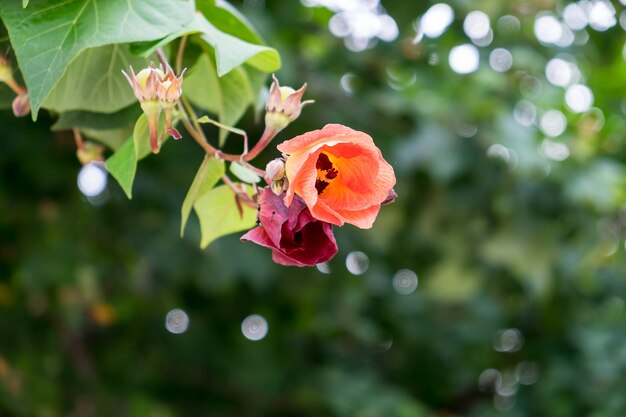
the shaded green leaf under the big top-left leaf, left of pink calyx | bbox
[42,45,154,113]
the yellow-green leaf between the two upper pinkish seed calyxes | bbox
[185,54,255,146]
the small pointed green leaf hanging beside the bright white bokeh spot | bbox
[105,114,164,199]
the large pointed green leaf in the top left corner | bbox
[0,0,194,119]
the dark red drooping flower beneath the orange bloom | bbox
[241,187,337,266]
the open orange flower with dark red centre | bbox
[278,124,396,229]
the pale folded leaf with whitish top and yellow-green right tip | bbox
[133,14,280,77]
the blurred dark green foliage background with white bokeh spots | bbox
[0,0,626,417]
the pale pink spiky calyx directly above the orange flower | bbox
[265,76,313,132]
